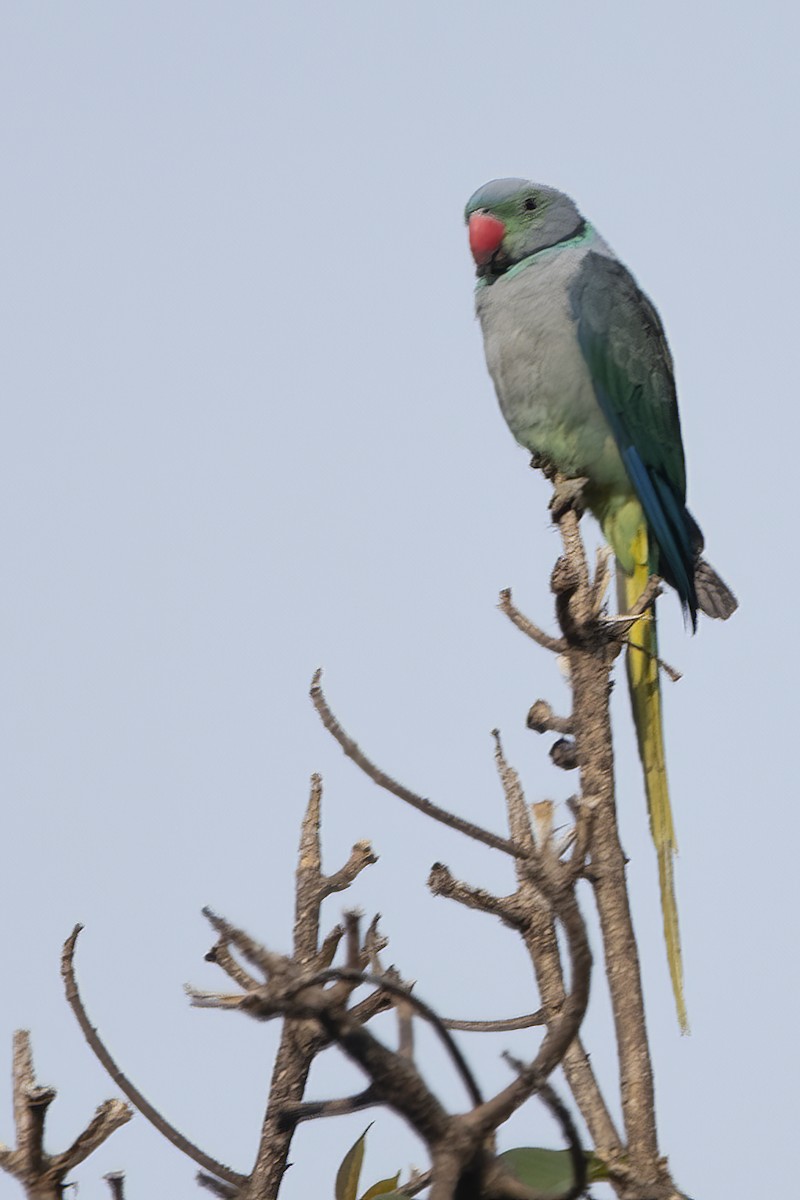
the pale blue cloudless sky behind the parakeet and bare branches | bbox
[0,0,800,1200]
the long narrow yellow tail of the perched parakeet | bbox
[619,526,688,1033]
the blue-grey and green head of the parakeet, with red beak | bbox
[464,179,585,280]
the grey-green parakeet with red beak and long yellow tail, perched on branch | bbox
[465,179,736,1030]
